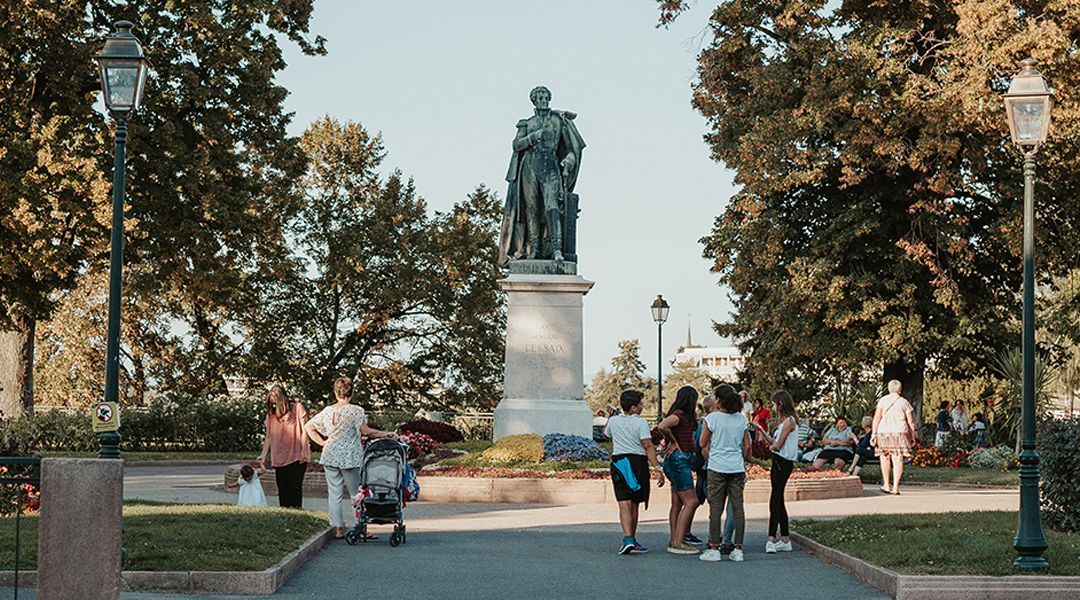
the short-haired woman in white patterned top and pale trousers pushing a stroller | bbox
[303,377,396,538]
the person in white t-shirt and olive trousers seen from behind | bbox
[699,384,750,562]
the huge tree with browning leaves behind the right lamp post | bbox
[660,0,1080,427]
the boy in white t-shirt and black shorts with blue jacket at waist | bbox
[604,390,664,555]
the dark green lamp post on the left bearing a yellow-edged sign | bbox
[94,21,150,459]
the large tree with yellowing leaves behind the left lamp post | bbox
[0,0,323,414]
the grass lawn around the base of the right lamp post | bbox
[792,512,1080,575]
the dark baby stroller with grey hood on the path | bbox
[345,439,408,546]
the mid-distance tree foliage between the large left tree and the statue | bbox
[248,118,505,409]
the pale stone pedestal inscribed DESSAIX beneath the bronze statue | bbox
[495,274,593,439]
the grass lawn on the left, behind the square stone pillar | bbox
[0,503,326,571]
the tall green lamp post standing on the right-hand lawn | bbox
[1004,58,1054,571]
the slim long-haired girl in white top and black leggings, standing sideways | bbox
[765,390,799,554]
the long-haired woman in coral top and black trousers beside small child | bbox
[256,383,311,508]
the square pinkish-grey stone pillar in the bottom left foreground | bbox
[38,459,124,600]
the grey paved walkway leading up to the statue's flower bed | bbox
[0,466,1018,600]
